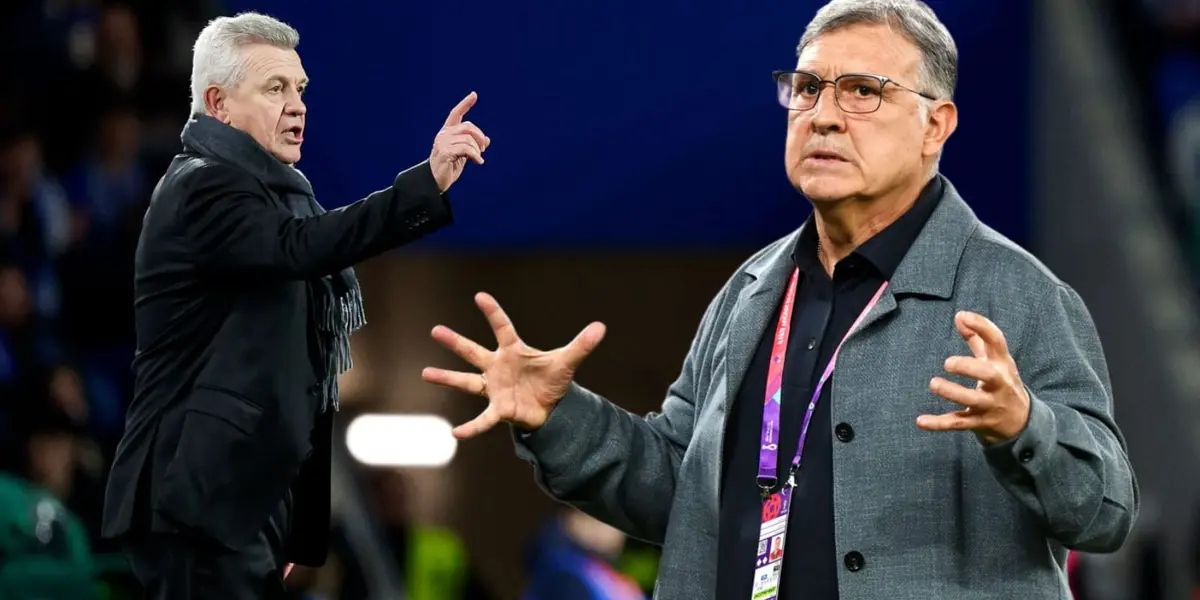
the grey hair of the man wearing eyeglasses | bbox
[796,0,959,107]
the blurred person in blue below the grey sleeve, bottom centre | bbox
[522,509,646,600]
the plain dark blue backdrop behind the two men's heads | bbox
[229,0,1030,248]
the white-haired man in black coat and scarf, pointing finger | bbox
[103,13,490,600]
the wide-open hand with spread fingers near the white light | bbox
[421,293,605,439]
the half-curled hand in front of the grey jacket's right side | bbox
[917,311,1030,445]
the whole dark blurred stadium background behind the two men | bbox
[0,0,1200,600]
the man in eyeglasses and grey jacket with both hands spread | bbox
[424,0,1139,600]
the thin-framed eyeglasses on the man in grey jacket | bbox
[772,71,937,114]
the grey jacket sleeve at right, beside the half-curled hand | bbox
[984,284,1139,552]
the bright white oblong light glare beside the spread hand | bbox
[346,414,458,467]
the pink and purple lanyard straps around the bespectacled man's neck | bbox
[757,269,888,499]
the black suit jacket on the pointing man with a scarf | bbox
[103,154,452,566]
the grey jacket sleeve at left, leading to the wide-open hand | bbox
[514,285,725,544]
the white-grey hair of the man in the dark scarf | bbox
[192,12,300,114]
